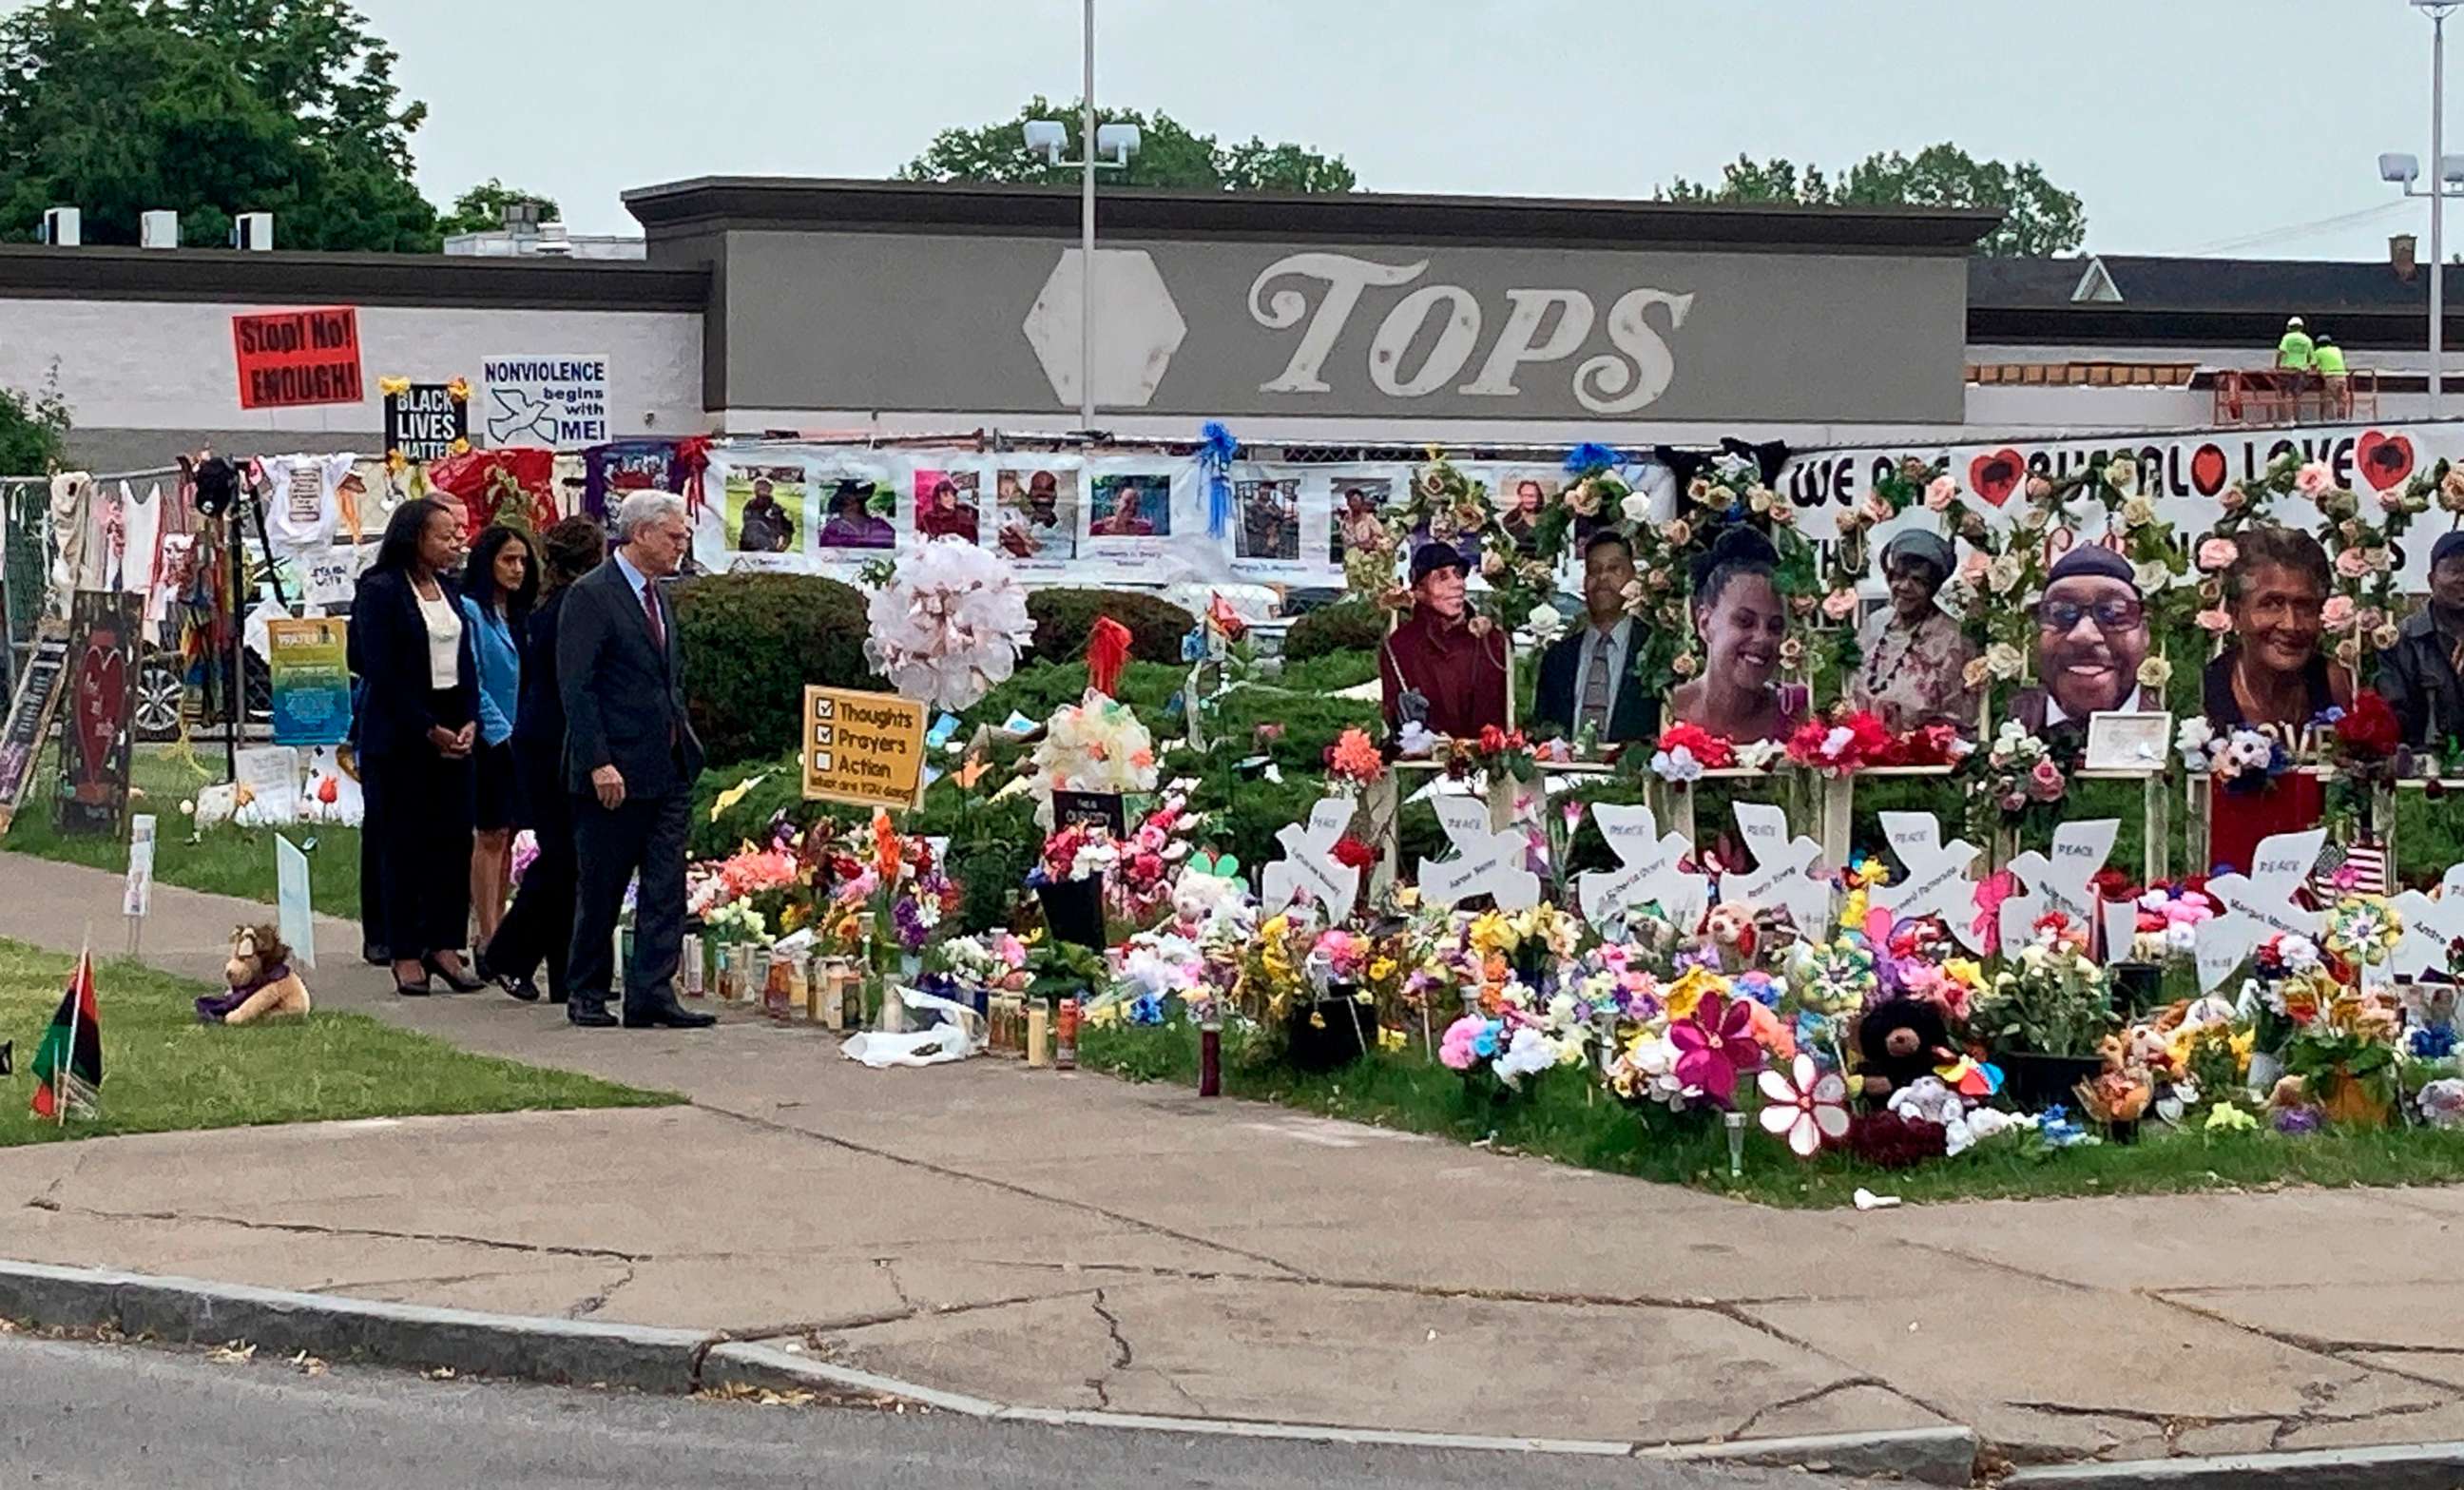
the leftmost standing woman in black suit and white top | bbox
[350,497,486,995]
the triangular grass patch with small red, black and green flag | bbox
[0,940,683,1145]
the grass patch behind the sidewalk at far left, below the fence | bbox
[0,744,359,921]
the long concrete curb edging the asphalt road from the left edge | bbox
[0,1261,1971,1490]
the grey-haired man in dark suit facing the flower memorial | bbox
[557,493,712,1030]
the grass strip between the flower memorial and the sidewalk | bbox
[1079,1022,2464,1207]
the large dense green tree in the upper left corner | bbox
[0,0,438,251]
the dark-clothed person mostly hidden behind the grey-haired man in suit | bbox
[478,517,608,1005]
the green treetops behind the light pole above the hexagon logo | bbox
[899,93,1360,192]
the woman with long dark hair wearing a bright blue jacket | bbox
[463,525,540,948]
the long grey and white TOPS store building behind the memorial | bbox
[0,180,2464,471]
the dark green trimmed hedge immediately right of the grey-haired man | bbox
[675,573,882,766]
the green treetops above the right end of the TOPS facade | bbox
[1661,143,2087,256]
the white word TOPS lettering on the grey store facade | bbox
[1249,254,1695,414]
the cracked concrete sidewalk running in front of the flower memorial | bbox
[0,855,2464,1461]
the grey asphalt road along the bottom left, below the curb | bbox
[0,1335,1819,1490]
